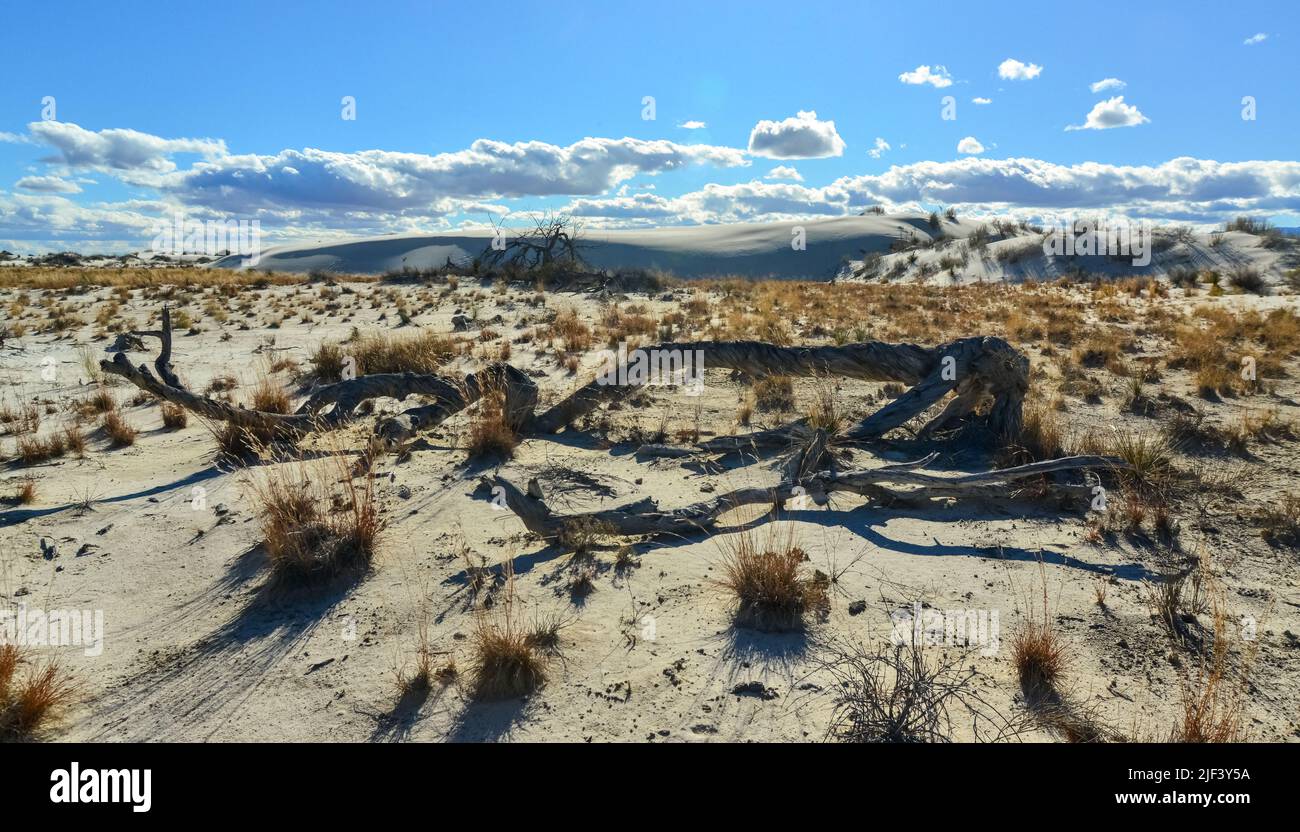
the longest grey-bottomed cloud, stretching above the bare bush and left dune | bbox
[163,138,750,216]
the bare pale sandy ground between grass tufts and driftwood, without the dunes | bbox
[0,271,1300,741]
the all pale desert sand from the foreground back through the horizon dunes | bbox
[0,217,1300,741]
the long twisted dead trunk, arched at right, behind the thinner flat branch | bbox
[100,308,1028,455]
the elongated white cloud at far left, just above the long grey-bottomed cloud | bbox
[27,121,226,176]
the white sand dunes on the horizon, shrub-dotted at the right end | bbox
[213,213,1300,285]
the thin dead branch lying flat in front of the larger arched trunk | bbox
[481,454,1125,538]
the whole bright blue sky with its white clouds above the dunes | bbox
[0,0,1300,251]
